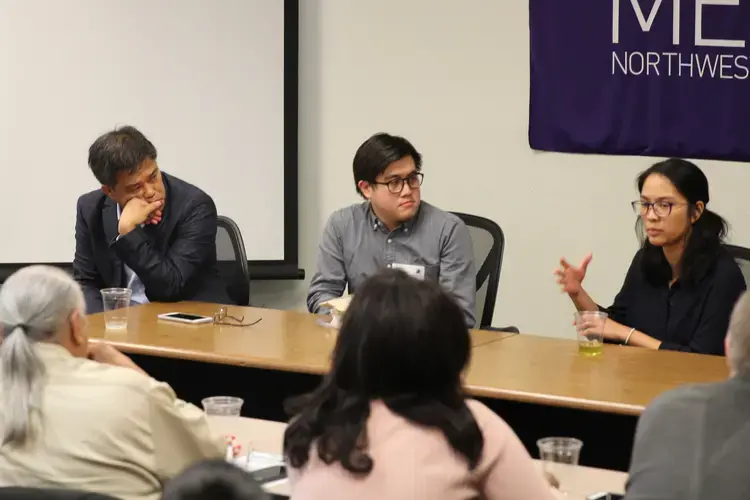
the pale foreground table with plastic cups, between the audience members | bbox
[209,416,627,500]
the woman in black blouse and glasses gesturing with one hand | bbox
[555,159,746,354]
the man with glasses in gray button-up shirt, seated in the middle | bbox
[307,134,476,327]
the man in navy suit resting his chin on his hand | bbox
[73,126,229,313]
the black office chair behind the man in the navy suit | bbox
[216,215,250,306]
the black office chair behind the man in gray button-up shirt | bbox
[453,212,518,333]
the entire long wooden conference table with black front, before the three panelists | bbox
[89,302,728,470]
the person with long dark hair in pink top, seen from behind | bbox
[284,271,557,500]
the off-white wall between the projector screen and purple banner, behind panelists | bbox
[253,0,750,336]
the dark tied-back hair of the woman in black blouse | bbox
[636,158,727,286]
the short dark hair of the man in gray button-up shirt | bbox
[352,132,422,195]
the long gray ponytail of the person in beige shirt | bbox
[0,325,44,447]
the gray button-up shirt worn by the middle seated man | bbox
[307,202,477,327]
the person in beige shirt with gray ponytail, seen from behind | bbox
[0,266,226,500]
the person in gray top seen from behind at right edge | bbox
[625,293,750,500]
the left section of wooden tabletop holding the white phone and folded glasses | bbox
[89,302,514,375]
